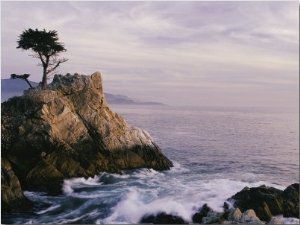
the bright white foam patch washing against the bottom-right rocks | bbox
[104,176,288,223]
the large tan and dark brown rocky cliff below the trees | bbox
[1,72,172,211]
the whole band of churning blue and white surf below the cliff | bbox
[18,159,295,224]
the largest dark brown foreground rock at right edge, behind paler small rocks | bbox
[229,183,299,221]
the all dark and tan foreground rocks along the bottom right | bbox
[140,183,299,225]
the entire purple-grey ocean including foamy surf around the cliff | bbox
[2,105,299,224]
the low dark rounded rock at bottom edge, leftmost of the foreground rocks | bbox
[140,212,187,224]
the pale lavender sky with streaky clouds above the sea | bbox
[1,1,299,108]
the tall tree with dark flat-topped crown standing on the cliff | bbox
[17,29,68,89]
